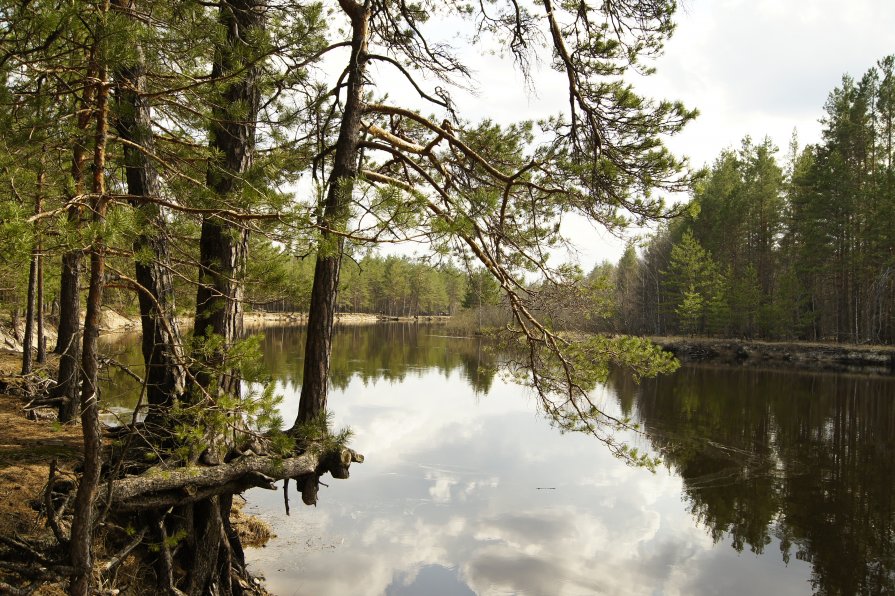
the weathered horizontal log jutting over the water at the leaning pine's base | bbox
[101,448,364,511]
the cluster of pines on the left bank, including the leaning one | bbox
[0,0,696,595]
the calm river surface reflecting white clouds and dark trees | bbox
[100,325,895,595]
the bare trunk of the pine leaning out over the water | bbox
[293,0,370,431]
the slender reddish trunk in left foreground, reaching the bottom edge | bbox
[69,18,109,596]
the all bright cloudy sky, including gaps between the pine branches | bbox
[374,0,895,271]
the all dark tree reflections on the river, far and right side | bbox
[103,324,895,594]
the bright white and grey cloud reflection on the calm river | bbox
[248,352,810,595]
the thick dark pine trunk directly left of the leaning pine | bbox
[176,0,264,596]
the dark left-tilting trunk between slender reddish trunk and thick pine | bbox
[115,0,186,416]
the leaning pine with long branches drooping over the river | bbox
[294,0,695,455]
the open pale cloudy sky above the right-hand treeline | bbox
[642,0,895,166]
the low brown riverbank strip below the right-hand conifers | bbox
[649,337,895,375]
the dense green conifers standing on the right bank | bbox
[590,56,895,343]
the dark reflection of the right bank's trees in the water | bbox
[613,368,895,594]
